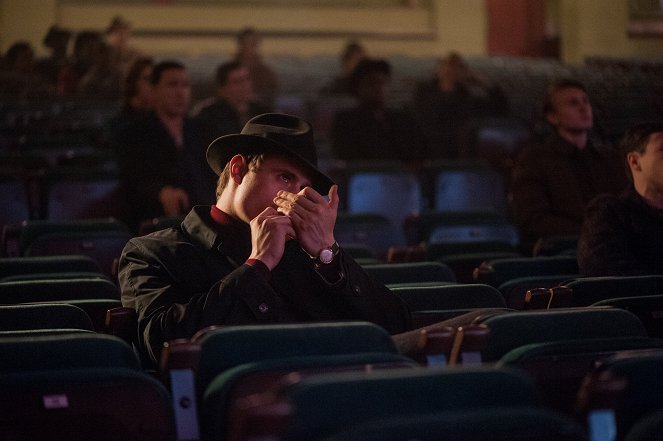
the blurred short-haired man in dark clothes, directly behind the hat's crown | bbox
[192,61,271,142]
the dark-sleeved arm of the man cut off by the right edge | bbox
[578,195,644,276]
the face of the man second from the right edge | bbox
[546,87,594,133]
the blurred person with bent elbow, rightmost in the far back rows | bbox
[413,52,508,159]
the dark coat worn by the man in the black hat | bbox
[119,205,410,362]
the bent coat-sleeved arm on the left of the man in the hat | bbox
[118,238,296,363]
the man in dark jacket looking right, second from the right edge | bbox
[511,79,626,248]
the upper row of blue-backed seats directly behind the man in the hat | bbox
[0,156,508,227]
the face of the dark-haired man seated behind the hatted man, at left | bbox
[154,68,191,117]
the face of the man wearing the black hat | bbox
[231,156,311,223]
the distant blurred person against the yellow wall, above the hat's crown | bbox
[234,28,279,108]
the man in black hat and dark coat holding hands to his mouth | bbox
[119,113,410,363]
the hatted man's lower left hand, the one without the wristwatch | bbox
[249,207,295,270]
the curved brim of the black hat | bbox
[206,134,335,196]
